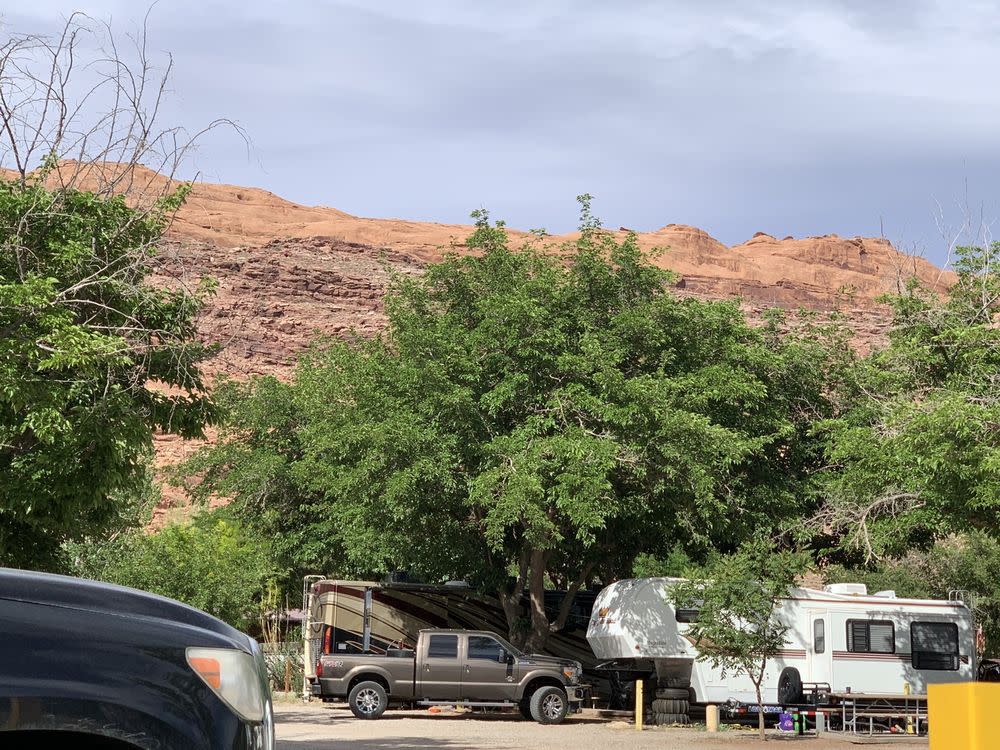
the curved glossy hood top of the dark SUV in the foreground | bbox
[0,568,252,650]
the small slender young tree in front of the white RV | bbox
[669,541,808,740]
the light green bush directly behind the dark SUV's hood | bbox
[69,510,280,631]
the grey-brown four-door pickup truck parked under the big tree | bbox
[311,630,588,724]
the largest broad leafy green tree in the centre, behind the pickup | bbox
[187,196,831,648]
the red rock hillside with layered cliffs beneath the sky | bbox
[0,164,953,516]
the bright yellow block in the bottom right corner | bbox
[927,682,1000,750]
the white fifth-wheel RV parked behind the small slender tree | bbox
[587,578,976,705]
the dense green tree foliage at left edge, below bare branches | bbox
[0,179,211,567]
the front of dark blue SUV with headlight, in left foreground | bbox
[0,568,274,750]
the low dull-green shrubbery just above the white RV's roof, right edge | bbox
[824,531,1000,657]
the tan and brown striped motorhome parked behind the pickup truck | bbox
[303,576,596,696]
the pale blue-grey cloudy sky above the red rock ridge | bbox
[0,0,1000,261]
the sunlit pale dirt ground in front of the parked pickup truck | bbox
[275,703,927,750]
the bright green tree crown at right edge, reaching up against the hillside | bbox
[819,243,1000,559]
